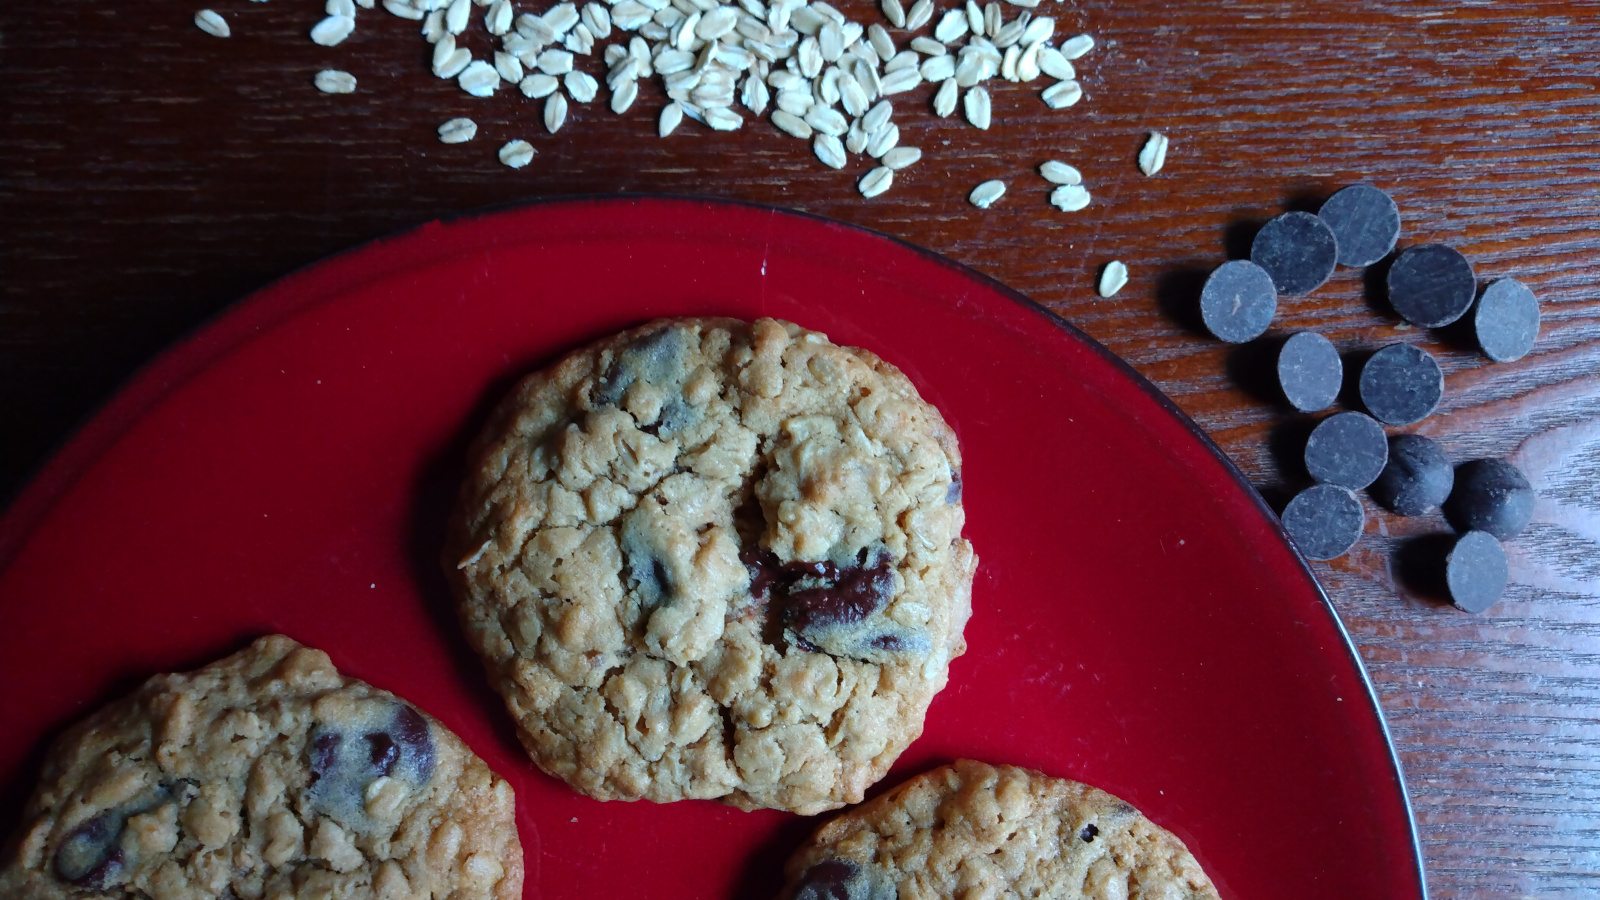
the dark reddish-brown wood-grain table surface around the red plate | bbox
[0,0,1600,898]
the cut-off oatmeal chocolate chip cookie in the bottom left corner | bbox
[0,636,522,900]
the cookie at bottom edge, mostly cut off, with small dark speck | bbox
[782,759,1218,900]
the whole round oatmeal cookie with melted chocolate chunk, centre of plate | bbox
[445,319,976,814]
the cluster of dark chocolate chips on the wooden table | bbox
[1200,184,1539,612]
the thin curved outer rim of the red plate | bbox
[0,194,1429,900]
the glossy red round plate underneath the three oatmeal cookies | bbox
[0,199,1424,900]
